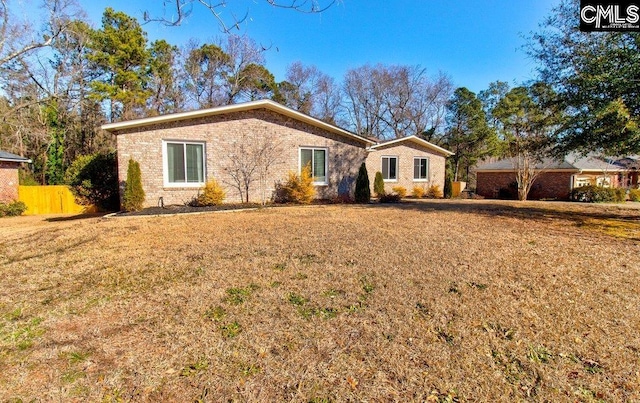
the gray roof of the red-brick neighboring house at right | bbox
[476,154,624,172]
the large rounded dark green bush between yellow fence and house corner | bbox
[65,151,120,211]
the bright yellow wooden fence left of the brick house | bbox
[18,186,97,215]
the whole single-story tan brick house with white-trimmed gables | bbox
[102,100,450,207]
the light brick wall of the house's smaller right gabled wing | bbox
[367,141,446,195]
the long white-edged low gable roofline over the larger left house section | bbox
[102,99,375,145]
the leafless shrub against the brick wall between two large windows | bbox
[222,132,283,205]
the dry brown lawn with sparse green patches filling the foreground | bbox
[0,201,640,402]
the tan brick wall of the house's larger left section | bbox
[117,109,367,207]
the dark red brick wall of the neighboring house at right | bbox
[476,172,574,200]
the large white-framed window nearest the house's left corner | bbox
[163,141,204,186]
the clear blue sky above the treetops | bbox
[80,0,560,92]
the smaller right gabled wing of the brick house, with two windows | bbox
[367,136,453,194]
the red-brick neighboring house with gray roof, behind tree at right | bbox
[476,154,624,200]
